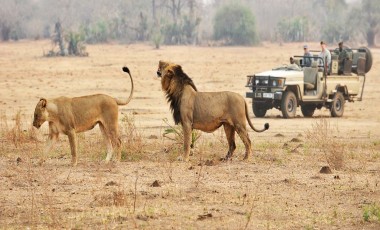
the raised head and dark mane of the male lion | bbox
[157,61,197,124]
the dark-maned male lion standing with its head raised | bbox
[157,61,269,161]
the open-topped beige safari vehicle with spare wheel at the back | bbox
[246,47,372,118]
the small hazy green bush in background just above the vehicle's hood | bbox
[277,17,309,42]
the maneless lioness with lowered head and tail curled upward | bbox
[33,67,134,166]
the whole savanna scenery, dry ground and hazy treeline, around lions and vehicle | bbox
[0,0,380,229]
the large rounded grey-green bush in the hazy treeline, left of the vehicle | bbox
[214,4,258,45]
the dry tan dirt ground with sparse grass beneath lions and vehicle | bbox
[0,41,380,229]
